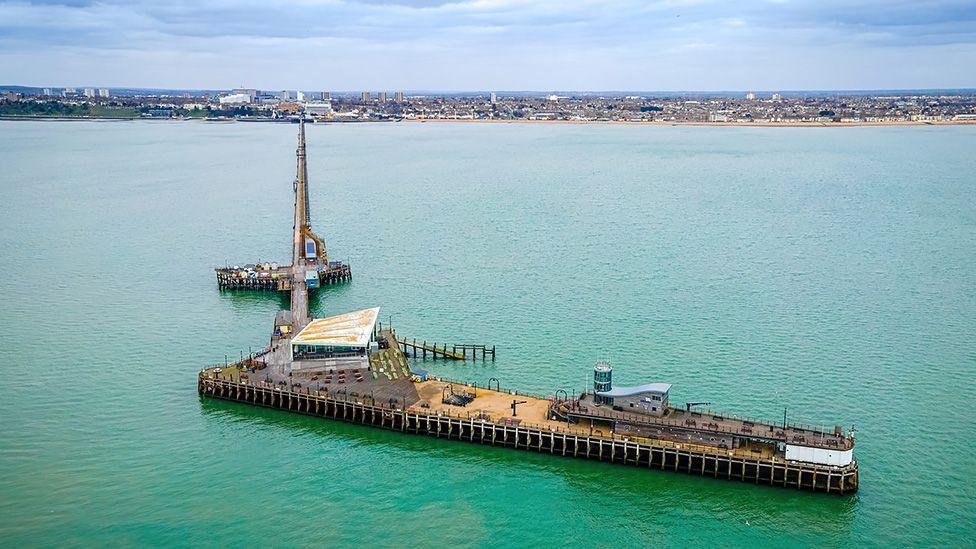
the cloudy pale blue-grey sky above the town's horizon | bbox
[0,0,976,91]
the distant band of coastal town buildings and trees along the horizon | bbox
[0,87,976,124]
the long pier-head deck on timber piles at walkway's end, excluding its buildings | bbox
[197,318,858,495]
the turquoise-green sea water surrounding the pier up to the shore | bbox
[0,122,976,547]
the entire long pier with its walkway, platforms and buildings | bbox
[197,120,858,495]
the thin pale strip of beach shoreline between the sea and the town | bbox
[0,115,976,128]
